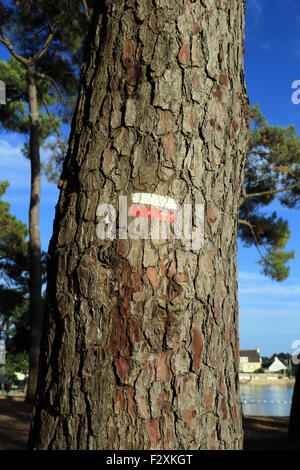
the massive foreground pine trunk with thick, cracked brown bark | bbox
[29,0,249,449]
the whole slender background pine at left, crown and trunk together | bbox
[0,0,90,402]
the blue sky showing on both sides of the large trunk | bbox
[0,0,300,356]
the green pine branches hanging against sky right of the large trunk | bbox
[239,105,300,281]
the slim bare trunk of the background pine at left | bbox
[26,66,43,403]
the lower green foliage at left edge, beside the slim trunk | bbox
[0,181,41,378]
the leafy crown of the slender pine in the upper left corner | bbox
[0,0,92,180]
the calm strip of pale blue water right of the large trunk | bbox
[240,384,294,416]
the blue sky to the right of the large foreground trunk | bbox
[238,0,300,355]
